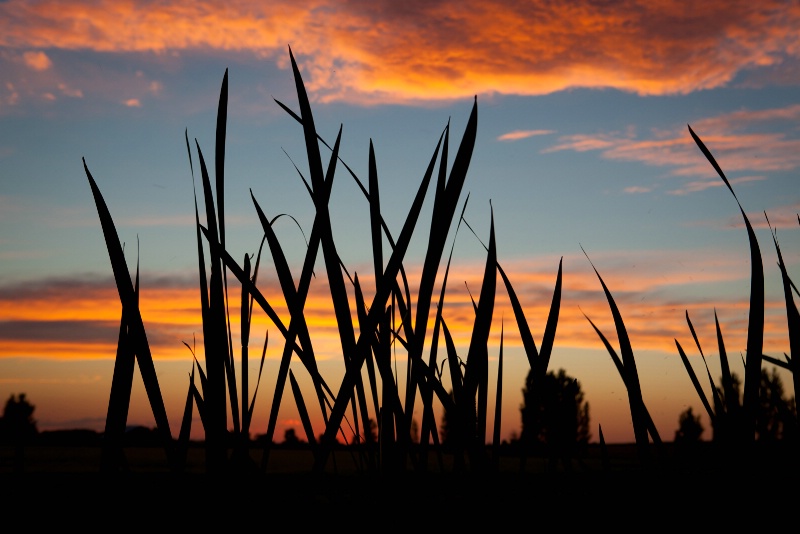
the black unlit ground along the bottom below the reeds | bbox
[0,446,800,532]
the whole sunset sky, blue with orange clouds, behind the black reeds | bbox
[0,0,800,448]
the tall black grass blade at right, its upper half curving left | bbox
[688,126,764,442]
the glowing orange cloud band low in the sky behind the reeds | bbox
[0,259,788,361]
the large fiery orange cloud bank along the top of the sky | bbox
[0,0,800,103]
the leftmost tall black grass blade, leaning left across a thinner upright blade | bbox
[83,160,175,468]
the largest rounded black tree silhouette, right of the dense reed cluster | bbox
[520,369,590,465]
